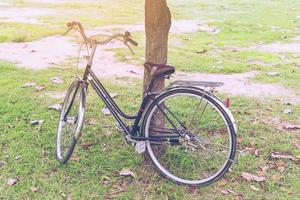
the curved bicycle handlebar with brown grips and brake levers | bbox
[64,21,138,50]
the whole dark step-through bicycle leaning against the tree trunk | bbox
[56,22,237,186]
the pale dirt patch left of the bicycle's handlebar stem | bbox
[0,36,78,69]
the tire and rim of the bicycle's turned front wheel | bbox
[56,81,86,164]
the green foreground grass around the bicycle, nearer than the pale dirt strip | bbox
[0,62,300,199]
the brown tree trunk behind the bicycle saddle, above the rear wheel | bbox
[144,0,171,92]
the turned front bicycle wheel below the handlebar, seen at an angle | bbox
[56,81,86,164]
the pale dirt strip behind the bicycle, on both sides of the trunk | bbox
[0,33,300,103]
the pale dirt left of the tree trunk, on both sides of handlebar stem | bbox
[0,36,143,77]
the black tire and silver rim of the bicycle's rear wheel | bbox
[142,87,236,186]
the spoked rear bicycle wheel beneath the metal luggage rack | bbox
[142,88,236,186]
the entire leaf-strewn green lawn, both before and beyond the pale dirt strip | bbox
[0,0,300,199]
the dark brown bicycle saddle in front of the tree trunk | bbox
[144,62,175,77]
